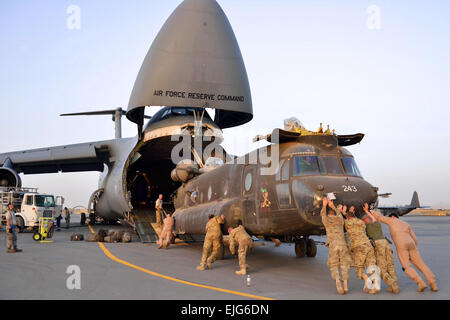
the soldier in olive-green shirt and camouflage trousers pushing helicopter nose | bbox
[362,203,400,293]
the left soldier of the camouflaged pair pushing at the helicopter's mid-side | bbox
[197,214,225,270]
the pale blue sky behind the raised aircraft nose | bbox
[0,0,450,208]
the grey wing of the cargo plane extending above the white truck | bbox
[0,140,117,174]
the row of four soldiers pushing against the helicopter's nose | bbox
[320,197,438,294]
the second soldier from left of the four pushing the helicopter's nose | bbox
[338,206,376,294]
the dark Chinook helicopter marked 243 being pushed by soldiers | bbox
[173,120,378,257]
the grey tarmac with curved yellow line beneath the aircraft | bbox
[0,216,450,300]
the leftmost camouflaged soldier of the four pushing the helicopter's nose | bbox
[320,197,351,294]
